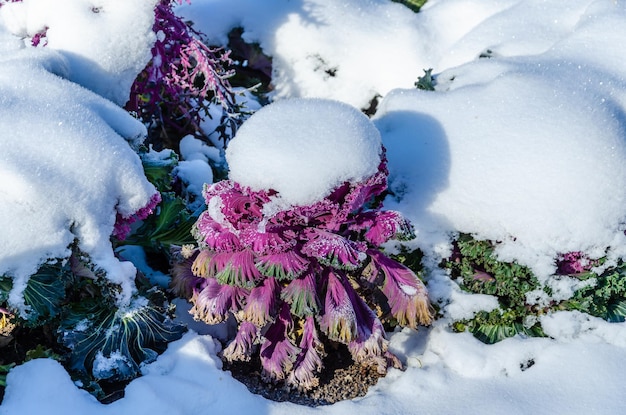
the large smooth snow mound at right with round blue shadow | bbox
[376,26,626,276]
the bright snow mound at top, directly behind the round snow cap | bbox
[177,0,434,108]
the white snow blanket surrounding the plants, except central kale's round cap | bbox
[0,0,626,415]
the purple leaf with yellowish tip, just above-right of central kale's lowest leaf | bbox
[319,271,357,344]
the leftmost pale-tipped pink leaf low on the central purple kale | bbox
[189,278,248,324]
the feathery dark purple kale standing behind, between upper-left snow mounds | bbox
[126,0,237,148]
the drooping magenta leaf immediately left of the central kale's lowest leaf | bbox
[259,303,300,381]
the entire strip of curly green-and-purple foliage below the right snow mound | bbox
[444,234,626,344]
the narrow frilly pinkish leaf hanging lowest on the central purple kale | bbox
[287,316,326,391]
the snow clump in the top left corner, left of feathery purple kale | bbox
[0,0,157,106]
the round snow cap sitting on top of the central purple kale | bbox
[226,99,381,205]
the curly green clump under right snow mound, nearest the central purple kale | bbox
[444,234,543,344]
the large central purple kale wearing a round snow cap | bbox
[172,100,431,390]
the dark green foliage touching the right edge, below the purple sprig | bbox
[561,261,626,323]
